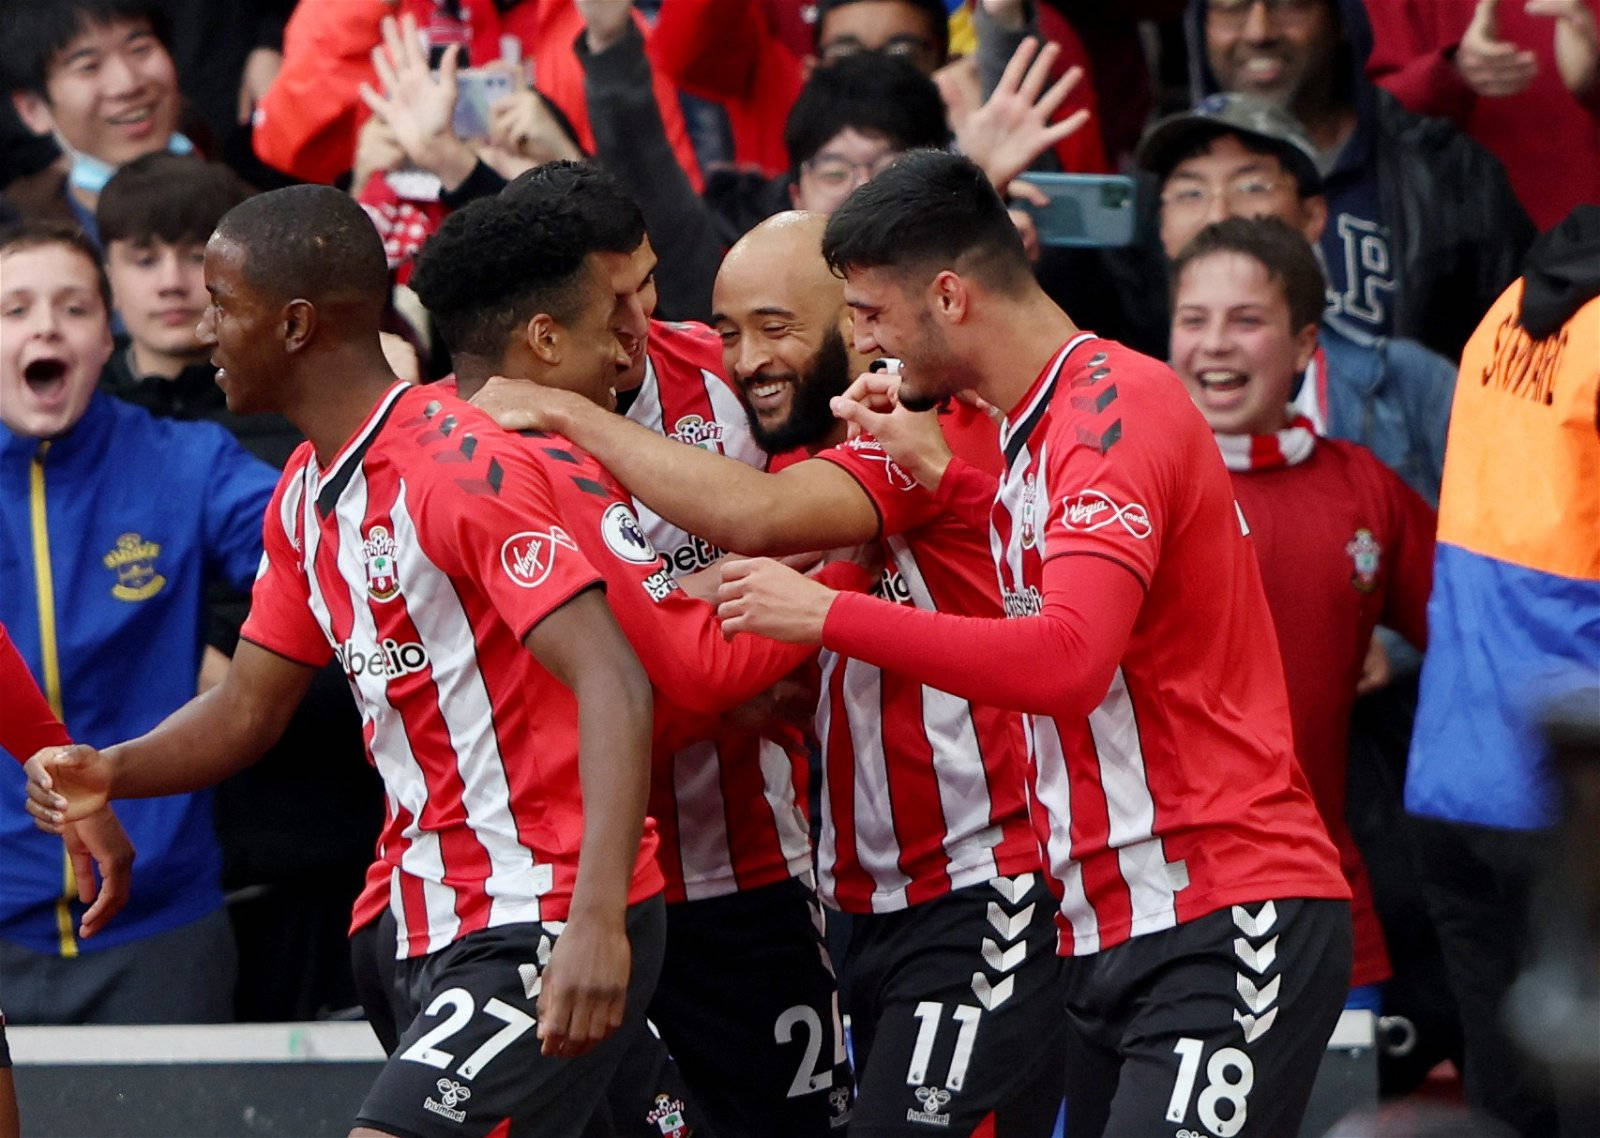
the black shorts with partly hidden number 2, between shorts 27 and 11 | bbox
[650,879,851,1138]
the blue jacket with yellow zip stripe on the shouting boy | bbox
[0,394,277,953]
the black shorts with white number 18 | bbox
[1062,900,1350,1138]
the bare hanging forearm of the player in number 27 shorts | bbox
[570,658,653,920]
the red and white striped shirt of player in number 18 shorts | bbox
[992,335,1349,954]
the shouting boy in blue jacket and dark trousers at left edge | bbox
[0,220,274,1023]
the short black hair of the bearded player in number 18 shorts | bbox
[822,150,1034,293]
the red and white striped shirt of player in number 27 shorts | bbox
[242,384,662,956]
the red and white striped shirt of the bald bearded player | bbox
[816,407,1038,912]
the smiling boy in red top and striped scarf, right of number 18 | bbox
[1171,218,1434,1010]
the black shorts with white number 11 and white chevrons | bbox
[843,874,1067,1138]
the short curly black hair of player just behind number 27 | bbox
[410,197,594,360]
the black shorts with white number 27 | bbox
[357,898,682,1138]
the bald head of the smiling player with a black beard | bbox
[712,211,861,453]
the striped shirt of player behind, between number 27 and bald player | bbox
[614,320,811,903]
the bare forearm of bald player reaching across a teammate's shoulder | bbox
[557,402,793,554]
